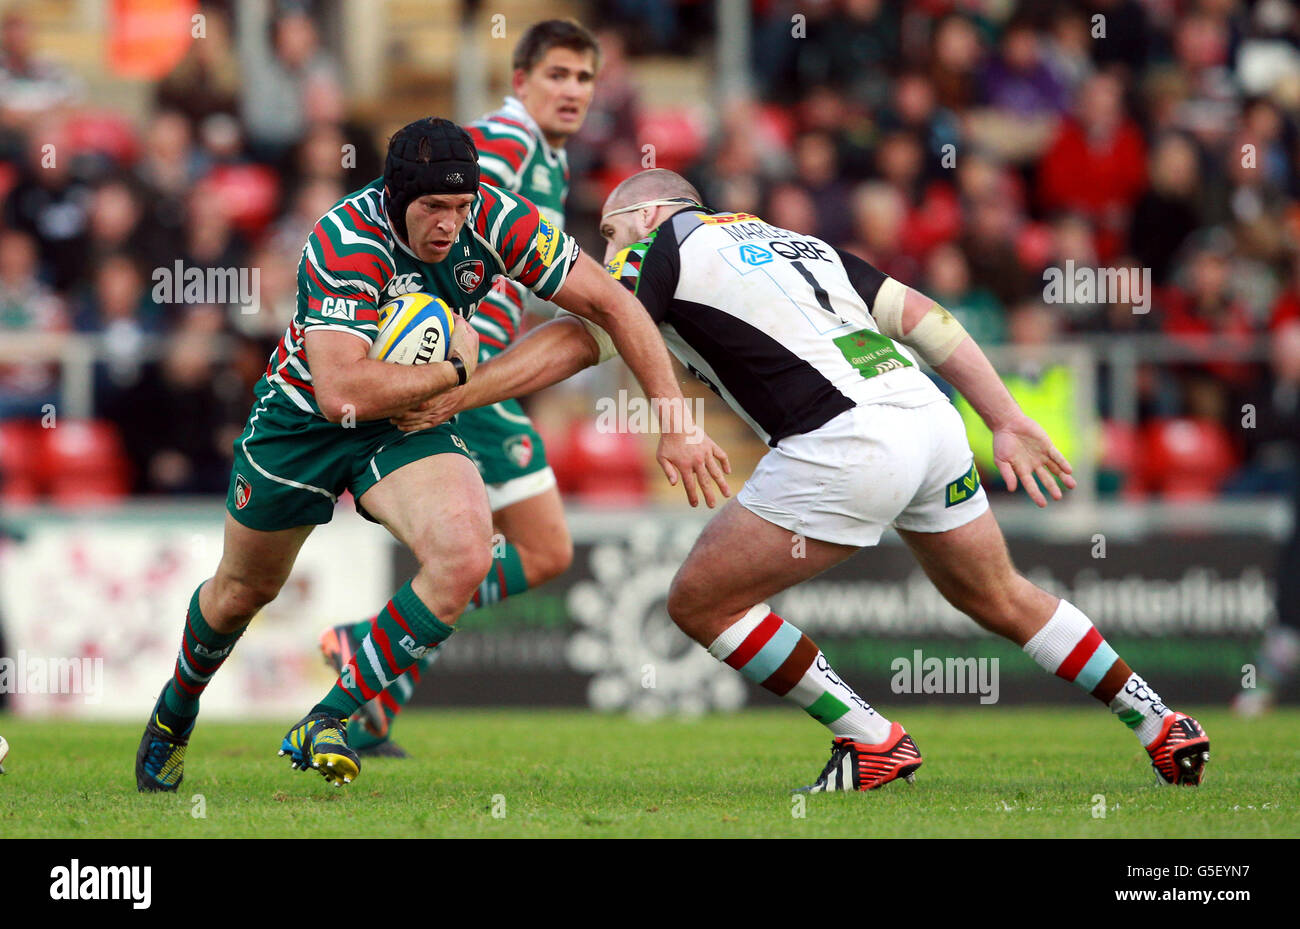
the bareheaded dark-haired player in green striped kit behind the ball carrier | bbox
[320,19,611,757]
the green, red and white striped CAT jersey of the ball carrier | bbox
[257,178,579,416]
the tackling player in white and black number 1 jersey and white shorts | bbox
[398,169,1209,791]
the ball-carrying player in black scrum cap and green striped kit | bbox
[135,118,729,791]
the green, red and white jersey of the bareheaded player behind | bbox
[465,96,569,360]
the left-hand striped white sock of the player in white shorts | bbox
[709,603,891,744]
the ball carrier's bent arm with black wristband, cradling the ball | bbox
[303,324,478,422]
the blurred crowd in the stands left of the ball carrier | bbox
[0,3,381,494]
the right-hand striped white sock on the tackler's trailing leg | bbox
[1024,599,1170,746]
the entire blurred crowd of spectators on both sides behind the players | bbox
[0,0,1300,501]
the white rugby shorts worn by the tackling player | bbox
[736,398,988,547]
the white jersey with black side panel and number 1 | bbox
[602,207,945,447]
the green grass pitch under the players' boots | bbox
[0,707,1300,838]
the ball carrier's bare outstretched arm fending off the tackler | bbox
[553,255,731,507]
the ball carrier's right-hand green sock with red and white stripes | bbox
[312,581,452,720]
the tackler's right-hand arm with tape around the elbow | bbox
[894,288,1075,507]
